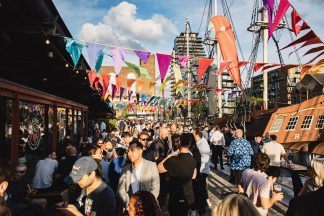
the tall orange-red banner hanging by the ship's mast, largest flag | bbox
[211,16,243,88]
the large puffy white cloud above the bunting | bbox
[79,1,177,48]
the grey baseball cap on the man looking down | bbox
[69,157,98,183]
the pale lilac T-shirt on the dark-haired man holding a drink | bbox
[241,169,271,216]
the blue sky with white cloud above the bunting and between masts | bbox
[53,0,324,82]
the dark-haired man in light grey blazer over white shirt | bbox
[118,142,160,209]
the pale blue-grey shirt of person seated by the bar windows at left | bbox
[33,158,58,189]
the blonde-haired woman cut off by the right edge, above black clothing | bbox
[298,158,324,196]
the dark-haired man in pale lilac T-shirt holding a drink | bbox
[240,153,283,216]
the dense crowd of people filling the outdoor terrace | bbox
[0,120,324,216]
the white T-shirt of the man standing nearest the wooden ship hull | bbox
[261,141,286,167]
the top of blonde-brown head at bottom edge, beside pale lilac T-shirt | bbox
[212,194,260,216]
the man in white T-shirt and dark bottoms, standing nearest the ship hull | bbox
[261,134,290,183]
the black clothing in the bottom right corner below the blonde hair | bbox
[286,187,324,216]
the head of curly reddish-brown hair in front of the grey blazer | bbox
[129,191,162,216]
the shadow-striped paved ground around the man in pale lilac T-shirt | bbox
[206,166,293,216]
